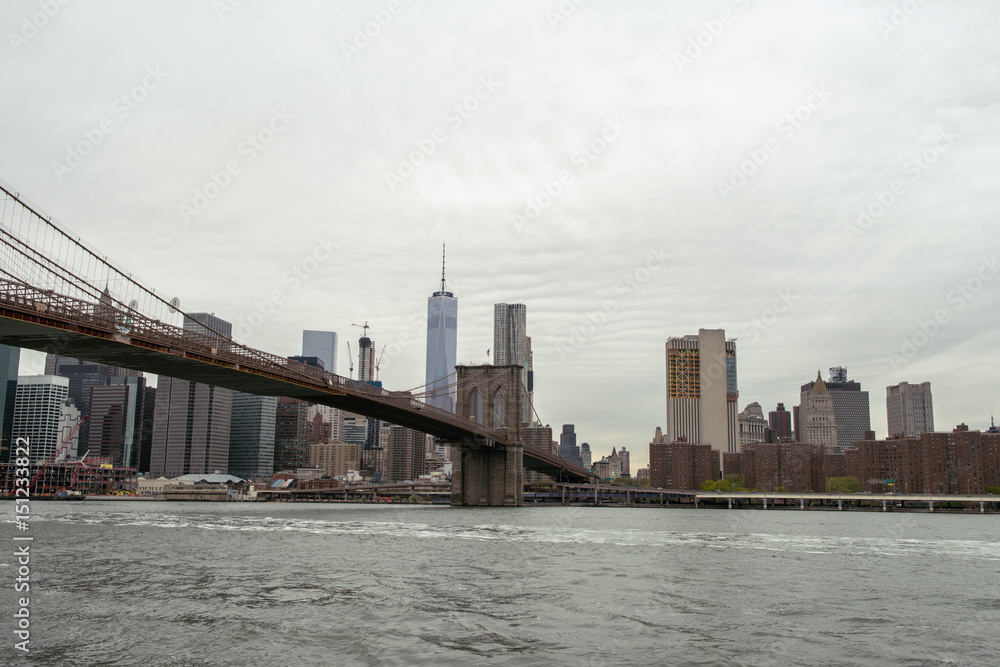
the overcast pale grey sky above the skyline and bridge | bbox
[0,0,1000,467]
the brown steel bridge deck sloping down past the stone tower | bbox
[0,279,590,482]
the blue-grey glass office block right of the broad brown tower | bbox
[229,391,278,479]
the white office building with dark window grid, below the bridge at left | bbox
[11,375,69,463]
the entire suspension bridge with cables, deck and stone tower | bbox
[0,182,590,506]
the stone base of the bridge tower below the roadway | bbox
[451,445,524,507]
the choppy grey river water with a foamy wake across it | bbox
[0,500,1000,667]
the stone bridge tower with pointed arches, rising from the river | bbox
[451,364,524,507]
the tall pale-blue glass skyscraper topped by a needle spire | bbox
[424,248,458,412]
